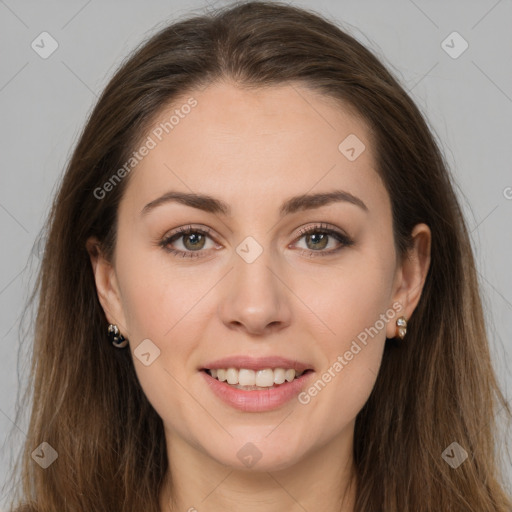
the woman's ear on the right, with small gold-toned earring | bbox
[386,224,432,338]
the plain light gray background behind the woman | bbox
[0,0,512,506]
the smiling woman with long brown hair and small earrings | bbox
[5,2,512,512]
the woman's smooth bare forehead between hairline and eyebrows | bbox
[118,82,387,221]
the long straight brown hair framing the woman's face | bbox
[5,2,512,512]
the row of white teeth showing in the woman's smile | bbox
[208,368,304,389]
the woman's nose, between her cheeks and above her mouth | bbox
[218,246,293,336]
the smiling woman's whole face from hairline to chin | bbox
[91,83,428,476]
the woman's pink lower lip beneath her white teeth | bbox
[201,371,313,412]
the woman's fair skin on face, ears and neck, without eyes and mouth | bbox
[88,82,431,512]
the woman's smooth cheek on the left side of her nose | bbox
[113,243,207,404]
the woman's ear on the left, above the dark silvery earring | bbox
[86,237,128,338]
